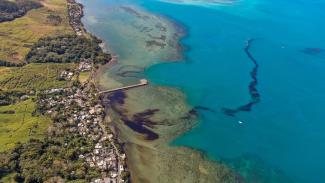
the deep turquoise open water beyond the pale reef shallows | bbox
[80,0,325,183]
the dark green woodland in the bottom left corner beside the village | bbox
[0,137,100,183]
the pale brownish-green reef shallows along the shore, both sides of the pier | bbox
[85,2,241,183]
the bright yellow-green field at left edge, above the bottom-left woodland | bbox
[0,99,51,152]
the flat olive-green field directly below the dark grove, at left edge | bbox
[0,63,75,90]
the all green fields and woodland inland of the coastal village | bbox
[0,0,111,183]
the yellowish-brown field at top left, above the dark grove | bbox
[0,0,73,63]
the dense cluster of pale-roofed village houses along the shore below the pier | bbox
[38,57,128,183]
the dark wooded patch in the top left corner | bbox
[0,0,42,23]
